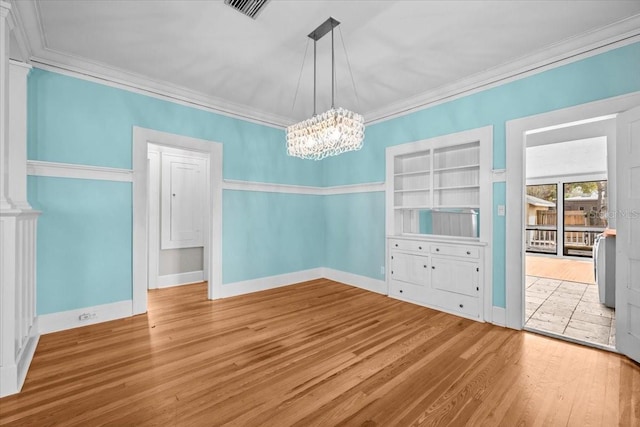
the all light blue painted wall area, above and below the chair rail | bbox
[28,43,640,314]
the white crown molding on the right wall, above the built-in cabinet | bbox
[365,14,640,124]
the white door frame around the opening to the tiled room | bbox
[505,91,640,330]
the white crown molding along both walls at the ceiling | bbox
[3,0,640,129]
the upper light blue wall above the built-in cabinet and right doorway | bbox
[323,43,640,186]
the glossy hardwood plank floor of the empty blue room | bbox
[0,280,640,426]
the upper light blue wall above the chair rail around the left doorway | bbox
[27,68,322,185]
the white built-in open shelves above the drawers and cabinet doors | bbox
[386,131,491,238]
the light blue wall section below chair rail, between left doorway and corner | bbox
[222,190,325,283]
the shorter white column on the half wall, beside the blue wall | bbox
[7,61,31,210]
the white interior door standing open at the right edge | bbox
[616,107,640,362]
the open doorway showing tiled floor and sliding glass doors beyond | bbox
[523,125,616,350]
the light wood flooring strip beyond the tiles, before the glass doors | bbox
[526,255,596,285]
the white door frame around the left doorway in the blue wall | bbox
[132,126,222,315]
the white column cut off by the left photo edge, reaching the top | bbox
[0,1,15,211]
